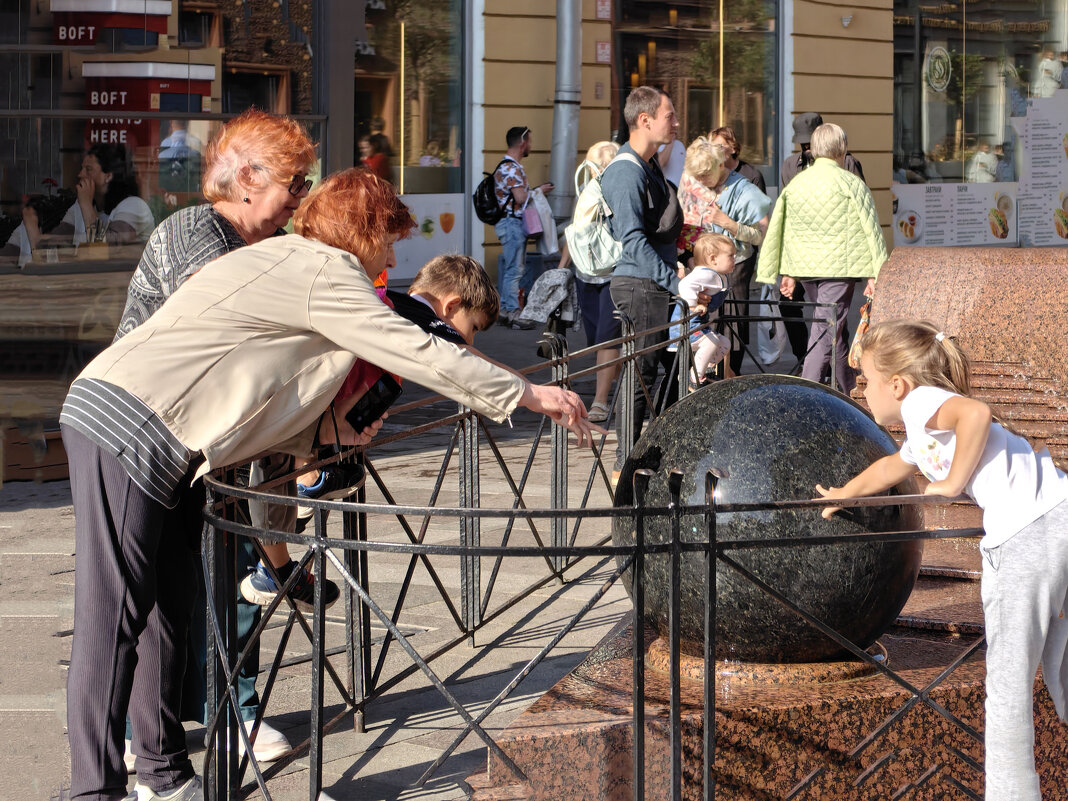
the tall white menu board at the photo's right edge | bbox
[1020,90,1068,247]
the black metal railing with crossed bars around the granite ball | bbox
[196,301,984,799]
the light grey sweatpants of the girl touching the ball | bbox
[983,501,1068,801]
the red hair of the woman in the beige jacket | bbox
[293,167,415,262]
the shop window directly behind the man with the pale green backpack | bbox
[613,0,779,186]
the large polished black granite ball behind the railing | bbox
[612,375,923,662]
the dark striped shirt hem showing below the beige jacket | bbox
[60,378,201,508]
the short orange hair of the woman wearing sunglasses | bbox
[201,109,317,203]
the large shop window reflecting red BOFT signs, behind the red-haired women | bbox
[0,0,323,425]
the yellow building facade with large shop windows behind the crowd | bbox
[0,0,1068,476]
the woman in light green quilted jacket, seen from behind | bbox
[756,123,888,394]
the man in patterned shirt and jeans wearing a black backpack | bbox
[484,125,552,327]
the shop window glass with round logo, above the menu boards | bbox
[894,0,1068,183]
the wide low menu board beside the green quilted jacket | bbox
[891,184,1020,246]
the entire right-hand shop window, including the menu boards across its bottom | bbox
[894,0,1068,245]
